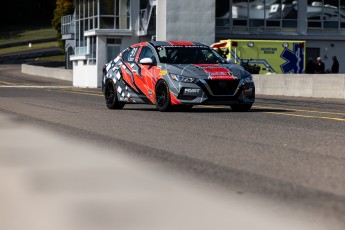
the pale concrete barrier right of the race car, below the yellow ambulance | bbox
[254,74,345,99]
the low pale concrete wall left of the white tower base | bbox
[22,64,73,81]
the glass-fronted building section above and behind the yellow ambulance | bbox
[216,0,345,73]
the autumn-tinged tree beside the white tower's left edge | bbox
[52,0,74,50]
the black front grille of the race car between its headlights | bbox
[206,80,239,96]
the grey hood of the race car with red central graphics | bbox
[163,64,250,80]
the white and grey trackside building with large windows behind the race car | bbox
[62,0,345,87]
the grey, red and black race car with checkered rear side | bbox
[102,41,255,112]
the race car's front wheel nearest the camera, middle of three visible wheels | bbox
[156,80,172,112]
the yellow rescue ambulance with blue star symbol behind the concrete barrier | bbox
[211,39,306,74]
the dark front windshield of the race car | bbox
[155,46,226,64]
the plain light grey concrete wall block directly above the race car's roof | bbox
[156,0,215,44]
